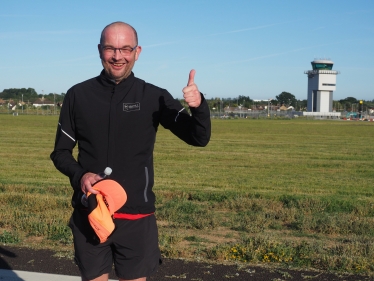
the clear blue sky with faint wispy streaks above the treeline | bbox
[0,0,374,101]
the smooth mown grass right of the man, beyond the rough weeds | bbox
[155,120,374,196]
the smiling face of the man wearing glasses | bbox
[98,25,141,84]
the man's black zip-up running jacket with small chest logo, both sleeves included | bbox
[51,72,211,214]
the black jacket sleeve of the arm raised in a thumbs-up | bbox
[160,93,211,146]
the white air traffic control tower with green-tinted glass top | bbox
[304,59,340,117]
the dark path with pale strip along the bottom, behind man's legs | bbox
[0,245,374,281]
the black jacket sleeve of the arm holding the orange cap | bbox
[50,90,87,190]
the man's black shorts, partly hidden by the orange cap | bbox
[69,209,161,279]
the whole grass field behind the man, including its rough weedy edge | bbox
[0,114,374,274]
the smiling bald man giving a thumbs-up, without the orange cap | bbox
[51,22,211,281]
